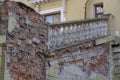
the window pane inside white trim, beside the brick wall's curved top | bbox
[45,13,60,23]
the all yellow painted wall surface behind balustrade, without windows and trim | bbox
[10,0,120,34]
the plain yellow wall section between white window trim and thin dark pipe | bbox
[66,0,85,21]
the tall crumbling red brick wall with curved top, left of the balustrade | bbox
[0,1,48,80]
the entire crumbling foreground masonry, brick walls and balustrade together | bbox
[0,1,113,80]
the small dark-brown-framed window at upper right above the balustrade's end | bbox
[95,3,104,17]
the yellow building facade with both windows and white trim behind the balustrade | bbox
[11,0,120,36]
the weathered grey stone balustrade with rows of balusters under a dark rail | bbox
[48,17,109,51]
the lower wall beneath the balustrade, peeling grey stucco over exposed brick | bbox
[47,42,111,80]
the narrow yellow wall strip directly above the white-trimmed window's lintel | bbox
[40,0,62,11]
